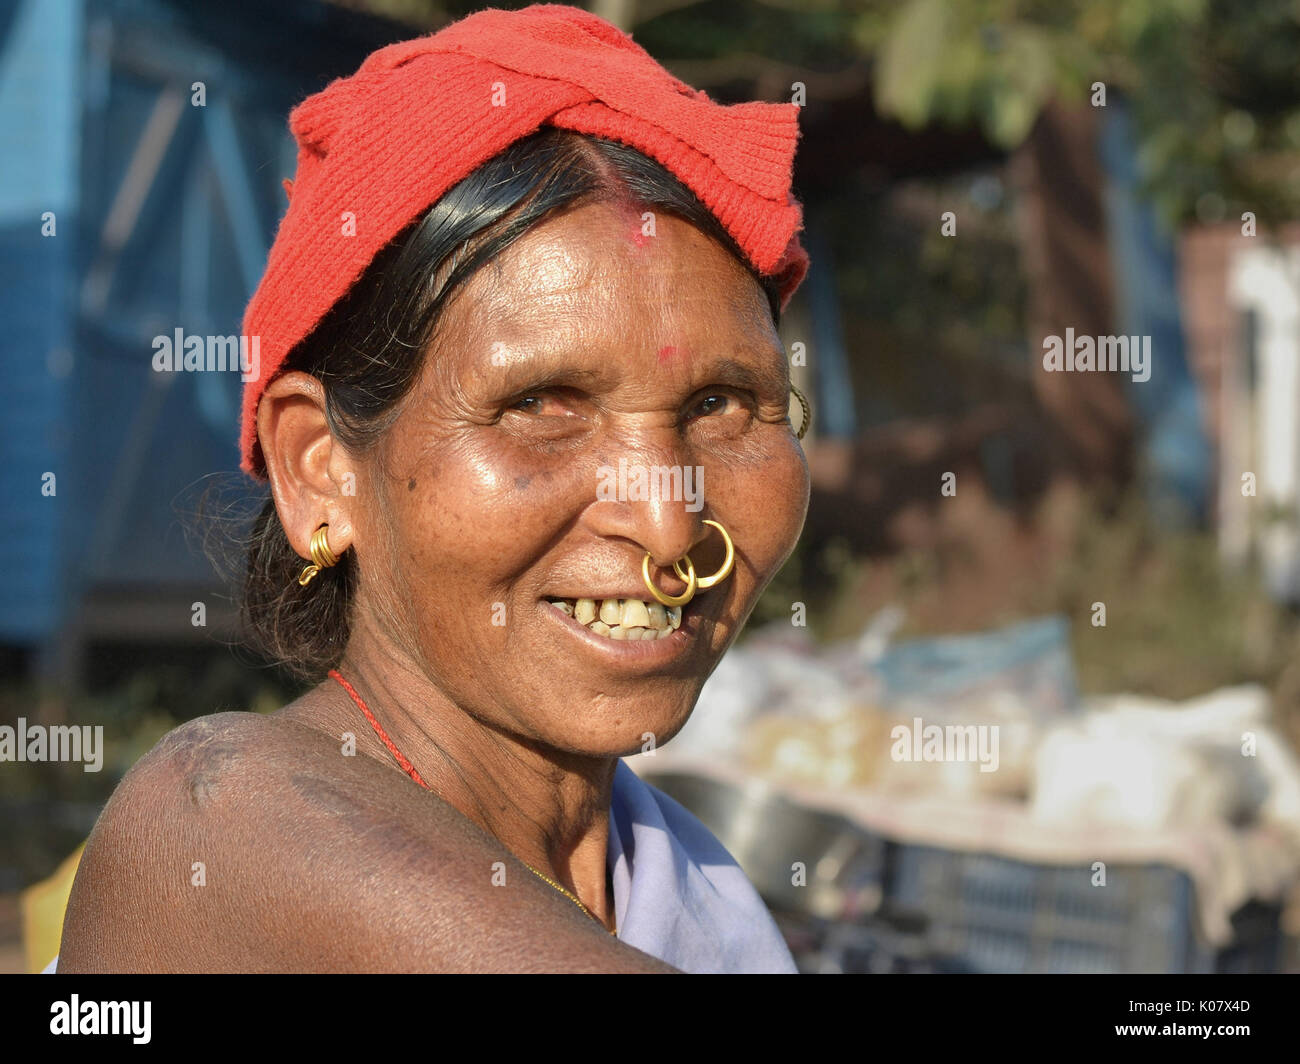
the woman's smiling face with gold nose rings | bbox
[352,196,809,756]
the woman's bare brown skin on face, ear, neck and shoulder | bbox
[60,199,809,972]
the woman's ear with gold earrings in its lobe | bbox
[257,371,356,558]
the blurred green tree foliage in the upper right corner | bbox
[854,0,1300,222]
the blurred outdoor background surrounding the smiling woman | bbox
[0,0,1300,973]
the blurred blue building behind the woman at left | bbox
[0,0,410,679]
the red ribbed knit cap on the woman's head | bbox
[239,4,809,477]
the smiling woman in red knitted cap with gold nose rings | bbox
[59,7,809,972]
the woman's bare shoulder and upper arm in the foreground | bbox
[59,713,675,973]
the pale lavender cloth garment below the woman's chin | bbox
[42,761,798,974]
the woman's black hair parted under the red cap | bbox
[241,129,780,680]
